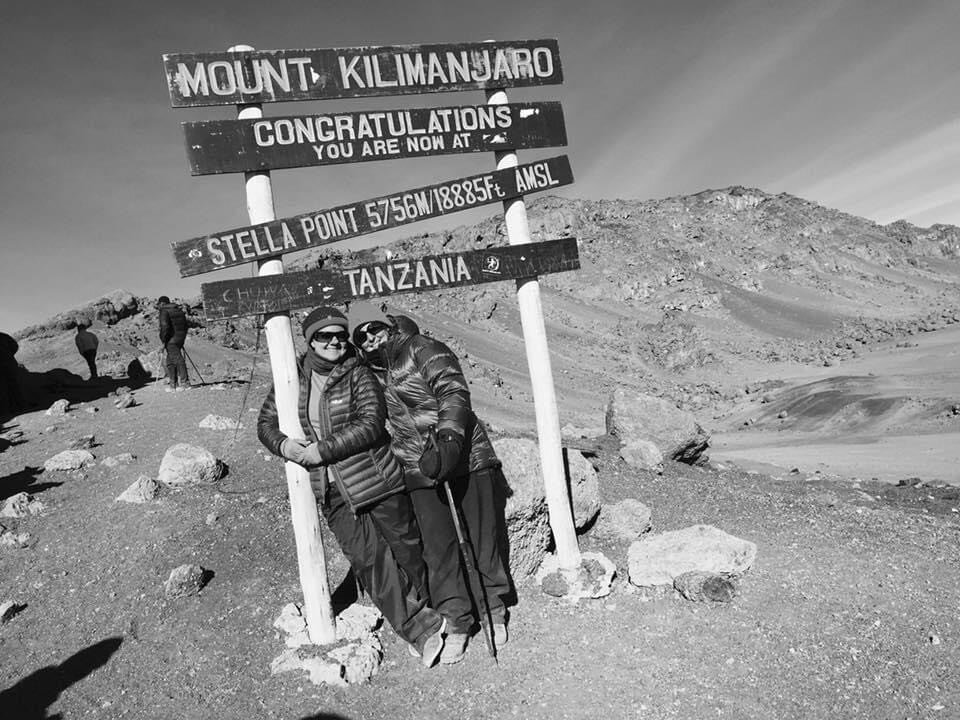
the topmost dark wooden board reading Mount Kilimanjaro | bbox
[163,40,563,107]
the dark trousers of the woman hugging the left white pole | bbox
[321,483,443,647]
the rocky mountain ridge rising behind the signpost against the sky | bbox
[9,186,960,434]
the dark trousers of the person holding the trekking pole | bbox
[410,467,510,633]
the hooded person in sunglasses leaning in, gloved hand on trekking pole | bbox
[350,302,510,664]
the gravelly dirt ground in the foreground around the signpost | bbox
[0,386,960,720]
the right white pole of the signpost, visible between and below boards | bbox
[487,90,581,571]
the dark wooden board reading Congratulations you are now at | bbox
[183,102,567,175]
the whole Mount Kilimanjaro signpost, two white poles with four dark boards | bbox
[164,40,581,645]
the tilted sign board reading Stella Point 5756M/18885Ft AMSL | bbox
[173,155,573,277]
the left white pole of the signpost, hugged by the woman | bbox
[230,45,337,645]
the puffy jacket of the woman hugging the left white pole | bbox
[257,357,404,513]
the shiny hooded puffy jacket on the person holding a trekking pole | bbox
[382,315,500,488]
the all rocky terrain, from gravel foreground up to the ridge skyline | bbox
[0,188,960,720]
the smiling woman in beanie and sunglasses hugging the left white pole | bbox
[257,306,445,667]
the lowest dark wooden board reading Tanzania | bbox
[201,238,580,320]
